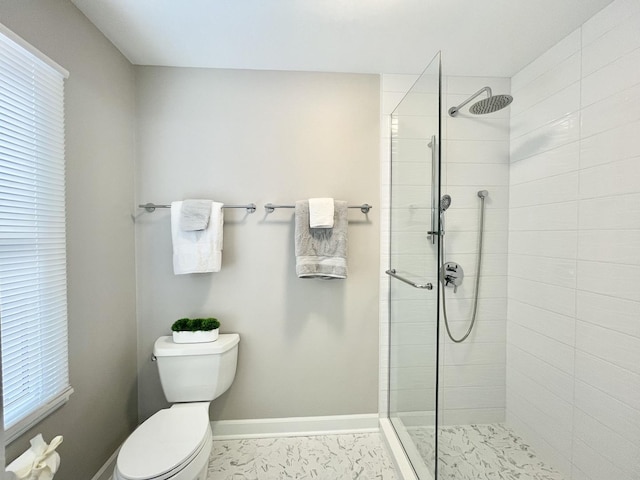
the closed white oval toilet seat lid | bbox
[117,403,211,480]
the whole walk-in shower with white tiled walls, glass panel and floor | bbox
[380,4,640,480]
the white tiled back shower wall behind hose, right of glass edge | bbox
[439,76,510,425]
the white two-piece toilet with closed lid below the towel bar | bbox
[113,333,240,480]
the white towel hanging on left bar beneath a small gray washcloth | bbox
[171,201,224,275]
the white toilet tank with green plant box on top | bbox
[153,333,240,403]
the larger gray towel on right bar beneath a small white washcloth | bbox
[295,200,348,279]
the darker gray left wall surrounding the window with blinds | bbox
[0,0,137,479]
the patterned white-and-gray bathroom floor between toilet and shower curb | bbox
[207,433,398,480]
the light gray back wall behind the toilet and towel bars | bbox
[136,67,379,419]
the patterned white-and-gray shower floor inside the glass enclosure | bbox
[408,423,565,480]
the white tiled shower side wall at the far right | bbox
[507,0,640,480]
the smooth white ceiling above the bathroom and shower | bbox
[72,0,612,77]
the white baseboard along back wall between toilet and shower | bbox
[211,413,378,440]
